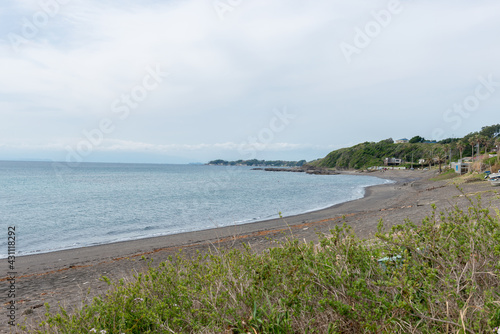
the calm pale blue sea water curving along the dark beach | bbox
[0,161,390,258]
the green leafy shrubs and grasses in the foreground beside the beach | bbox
[33,197,500,334]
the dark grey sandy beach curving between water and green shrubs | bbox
[0,170,500,333]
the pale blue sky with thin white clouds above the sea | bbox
[0,0,500,164]
